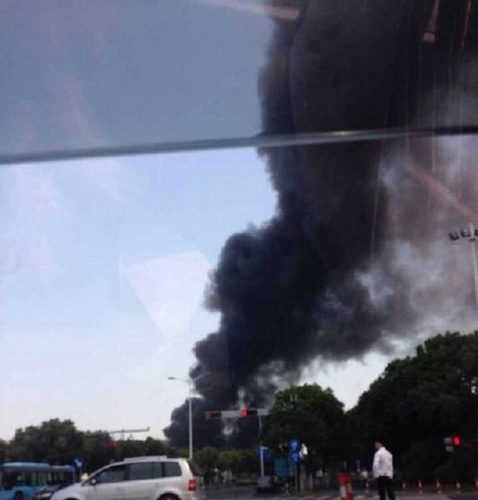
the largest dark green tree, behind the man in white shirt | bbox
[350,332,478,479]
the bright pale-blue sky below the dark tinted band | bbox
[0,149,387,439]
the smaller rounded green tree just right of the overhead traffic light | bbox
[264,384,347,471]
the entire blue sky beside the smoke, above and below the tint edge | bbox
[0,0,396,439]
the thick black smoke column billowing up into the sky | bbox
[165,0,478,441]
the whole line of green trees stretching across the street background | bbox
[0,331,478,482]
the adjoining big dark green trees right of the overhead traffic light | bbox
[263,332,478,482]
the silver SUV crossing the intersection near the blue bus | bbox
[52,457,206,500]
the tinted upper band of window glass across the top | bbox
[0,0,477,163]
